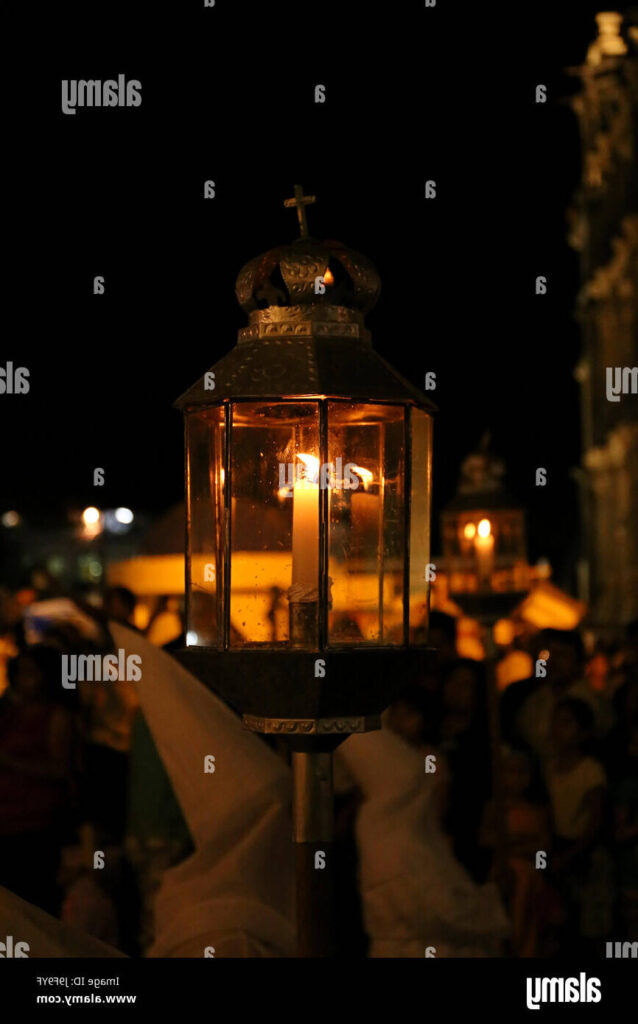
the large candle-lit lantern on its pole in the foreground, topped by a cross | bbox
[176,186,433,955]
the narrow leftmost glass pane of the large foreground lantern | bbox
[186,407,225,647]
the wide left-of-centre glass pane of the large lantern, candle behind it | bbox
[229,401,320,647]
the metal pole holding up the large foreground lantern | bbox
[292,751,336,957]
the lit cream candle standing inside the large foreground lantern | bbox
[291,455,320,601]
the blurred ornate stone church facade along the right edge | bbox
[568,8,638,639]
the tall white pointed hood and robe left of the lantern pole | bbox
[110,623,295,956]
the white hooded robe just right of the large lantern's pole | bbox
[336,728,509,957]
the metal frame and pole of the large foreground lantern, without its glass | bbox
[175,185,435,956]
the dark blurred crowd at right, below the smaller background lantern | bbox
[388,612,638,956]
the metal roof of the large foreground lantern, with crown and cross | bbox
[175,185,435,411]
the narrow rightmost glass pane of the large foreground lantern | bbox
[410,409,432,643]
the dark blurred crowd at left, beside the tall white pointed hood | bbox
[0,587,192,955]
